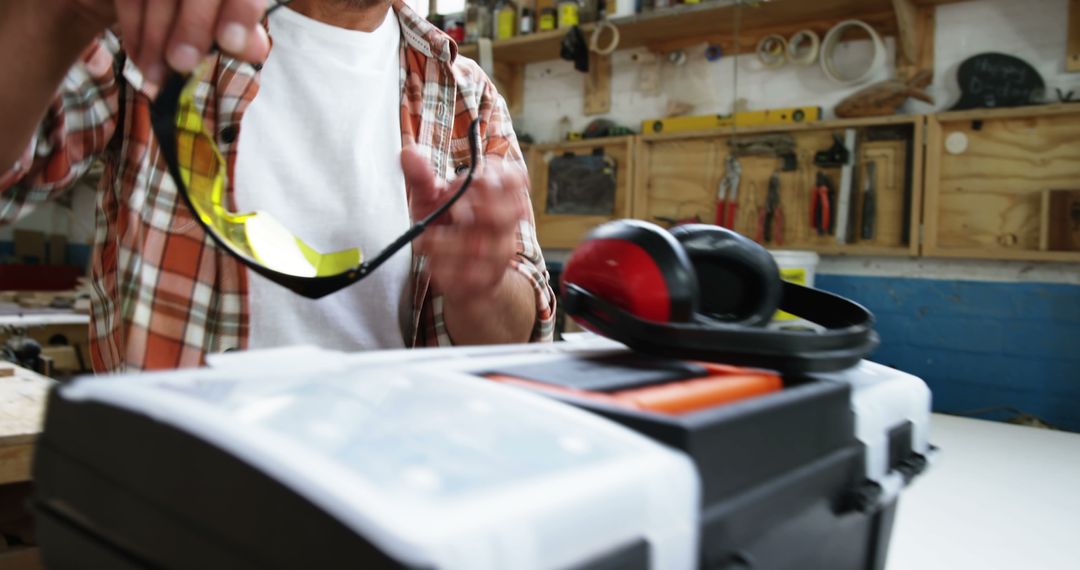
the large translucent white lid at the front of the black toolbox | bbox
[58,351,700,568]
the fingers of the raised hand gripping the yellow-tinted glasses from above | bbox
[58,0,270,86]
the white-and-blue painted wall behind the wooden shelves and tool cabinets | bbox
[516,0,1080,432]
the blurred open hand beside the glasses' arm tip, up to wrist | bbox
[402,147,529,302]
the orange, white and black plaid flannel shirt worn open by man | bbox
[0,0,555,372]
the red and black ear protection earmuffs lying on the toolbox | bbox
[562,220,878,374]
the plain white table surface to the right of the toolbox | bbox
[887,415,1080,570]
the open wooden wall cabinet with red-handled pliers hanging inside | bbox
[634,117,923,256]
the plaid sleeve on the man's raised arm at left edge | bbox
[0,33,120,226]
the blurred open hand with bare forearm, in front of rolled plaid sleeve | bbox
[402,147,536,344]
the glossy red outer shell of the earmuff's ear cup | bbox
[562,239,672,323]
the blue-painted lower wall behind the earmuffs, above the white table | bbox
[815,274,1080,432]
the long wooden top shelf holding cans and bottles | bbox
[459,0,961,64]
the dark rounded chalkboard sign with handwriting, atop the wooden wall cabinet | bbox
[953,53,1047,111]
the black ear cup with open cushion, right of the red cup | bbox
[672,225,783,326]
